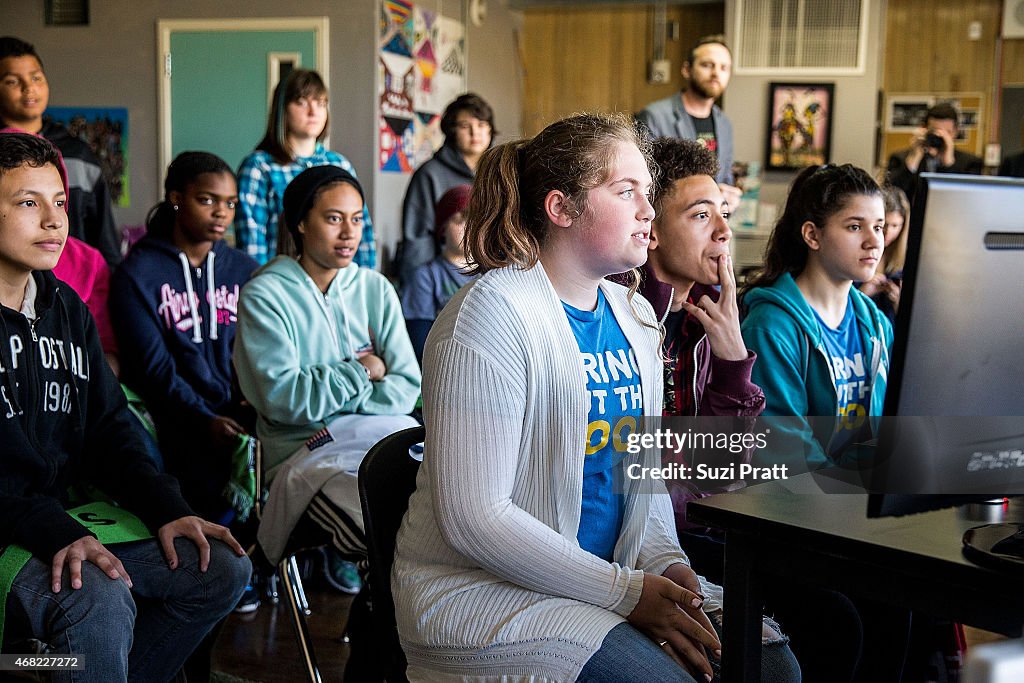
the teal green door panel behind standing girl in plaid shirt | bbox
[168,30,317,169]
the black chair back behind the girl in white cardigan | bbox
[358,427,425,683]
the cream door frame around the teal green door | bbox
[157,16,331,178]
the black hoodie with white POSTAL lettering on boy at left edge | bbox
[0,271,193,562]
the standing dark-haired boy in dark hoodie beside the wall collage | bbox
[399,92,497,285]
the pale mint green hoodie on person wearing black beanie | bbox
[233,256,420,469]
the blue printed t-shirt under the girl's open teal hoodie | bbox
[814,300,871,457]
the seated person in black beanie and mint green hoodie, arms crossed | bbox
[233,166,420,573]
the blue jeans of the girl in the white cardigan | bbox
[577,618,800,683]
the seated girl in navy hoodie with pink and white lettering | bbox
[110,152,257,516]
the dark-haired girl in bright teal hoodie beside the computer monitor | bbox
[741,164,893,474]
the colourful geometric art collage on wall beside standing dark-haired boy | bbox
[377,0,466,173]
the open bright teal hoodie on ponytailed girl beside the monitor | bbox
[741,273,893,474]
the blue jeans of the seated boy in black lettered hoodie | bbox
[7,539,252,683]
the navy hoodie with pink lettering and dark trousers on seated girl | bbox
[110,234,257,518]
